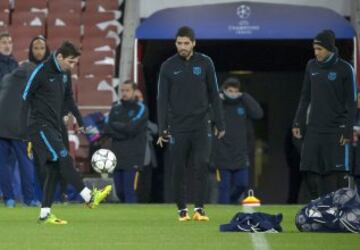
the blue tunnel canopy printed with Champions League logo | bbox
[136,2,355,40]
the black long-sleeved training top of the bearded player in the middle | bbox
[157,52,225,134]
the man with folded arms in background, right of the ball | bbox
[107,81,148,203]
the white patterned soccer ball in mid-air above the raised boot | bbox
[91,148,117,174]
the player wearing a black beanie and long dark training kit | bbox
[293,30,357,199]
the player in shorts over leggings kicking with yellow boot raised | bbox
[22,42,111,224]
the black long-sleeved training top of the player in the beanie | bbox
[293,53,357,139]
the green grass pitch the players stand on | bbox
[0,204,360,250]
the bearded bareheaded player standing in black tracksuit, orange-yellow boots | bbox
[157,27,225,221]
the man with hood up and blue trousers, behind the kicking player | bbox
[0,36,50,207]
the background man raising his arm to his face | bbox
[213,78,263,204]
